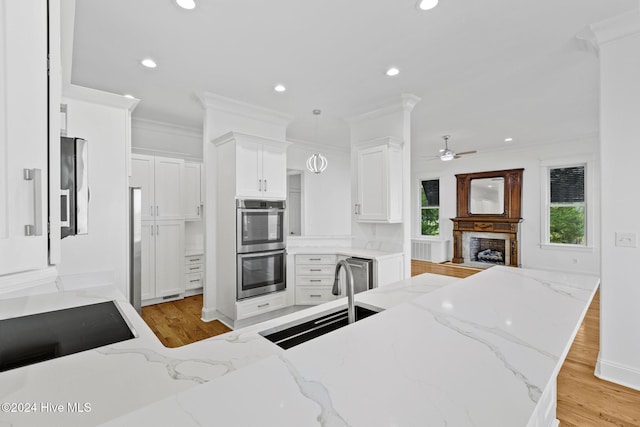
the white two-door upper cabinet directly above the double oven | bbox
[213,132,289,199]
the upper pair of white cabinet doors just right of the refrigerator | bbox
[130,154,185,220]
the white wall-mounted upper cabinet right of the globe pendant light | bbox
[354,137,402,223]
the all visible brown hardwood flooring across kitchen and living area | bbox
[142,263,640,427]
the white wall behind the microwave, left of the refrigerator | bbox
[58,86,135,295]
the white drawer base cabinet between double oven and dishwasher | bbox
[295,254,338,305]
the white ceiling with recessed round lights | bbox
[63,0,638,155]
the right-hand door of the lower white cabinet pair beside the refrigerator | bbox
[155,221,185,297]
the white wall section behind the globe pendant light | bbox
[287,143,351,236]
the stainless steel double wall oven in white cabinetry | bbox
[236,199,287,300]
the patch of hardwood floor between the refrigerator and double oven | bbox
[142,295,231,348]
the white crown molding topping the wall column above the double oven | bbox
[197,92,293,127]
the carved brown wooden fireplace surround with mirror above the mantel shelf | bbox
[451,169,524,267]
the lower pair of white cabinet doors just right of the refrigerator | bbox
[141,220,185,304]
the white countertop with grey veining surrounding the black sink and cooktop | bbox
[0,267,599,427]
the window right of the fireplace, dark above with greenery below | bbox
[548,165,587,246]
